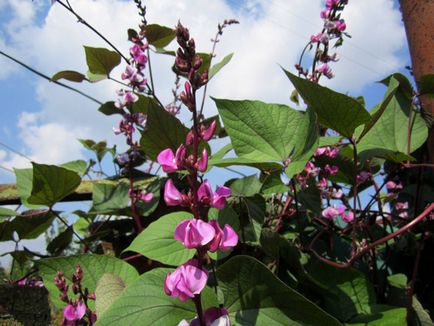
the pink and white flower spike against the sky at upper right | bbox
[295,0,348,82]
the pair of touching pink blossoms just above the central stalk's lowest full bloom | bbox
[174,219,238,252]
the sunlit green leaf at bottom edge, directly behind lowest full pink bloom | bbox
[96,268,218,326]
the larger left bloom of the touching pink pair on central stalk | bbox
[174,219,216,249]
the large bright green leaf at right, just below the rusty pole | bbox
[357,89,428,157]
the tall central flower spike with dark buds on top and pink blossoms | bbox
[157,23,238,325]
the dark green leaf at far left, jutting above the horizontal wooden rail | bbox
[28,162,81,207]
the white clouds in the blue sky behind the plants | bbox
[0,0,405,172]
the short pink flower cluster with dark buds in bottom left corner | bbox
[54,265,96,326]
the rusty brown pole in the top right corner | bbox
[400,0,434,163]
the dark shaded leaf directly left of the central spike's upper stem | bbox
[140,100,188,161]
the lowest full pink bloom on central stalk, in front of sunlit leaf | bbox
[164,259,208,301]
